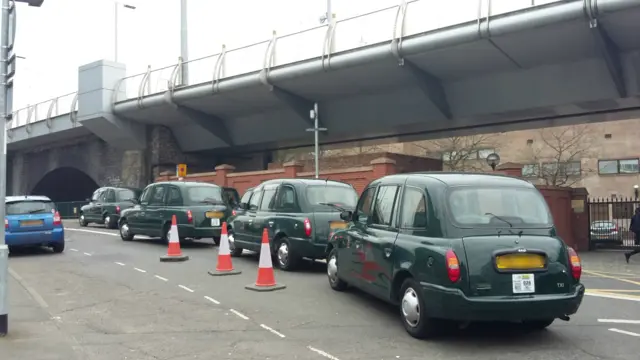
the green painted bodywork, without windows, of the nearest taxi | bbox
[327,173,585,321]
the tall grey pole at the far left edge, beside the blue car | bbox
[0,0,44,337]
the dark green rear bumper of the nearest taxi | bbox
[420,282,585,321]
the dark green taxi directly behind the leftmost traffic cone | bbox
[118,181,239,245]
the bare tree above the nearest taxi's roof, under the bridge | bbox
[414,134,499,172]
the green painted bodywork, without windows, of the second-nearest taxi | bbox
[229,179,357,259]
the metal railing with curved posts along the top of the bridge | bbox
[113,0,563,103]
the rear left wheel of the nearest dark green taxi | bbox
[400,278,440,339]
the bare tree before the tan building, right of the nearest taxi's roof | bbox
[523,125,594,186]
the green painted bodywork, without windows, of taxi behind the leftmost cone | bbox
[119,181,237,239]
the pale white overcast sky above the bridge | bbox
[14,0,556,110]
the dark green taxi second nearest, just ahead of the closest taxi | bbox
[229,179,358,270]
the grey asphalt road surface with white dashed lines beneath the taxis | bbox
[0,222,640,360]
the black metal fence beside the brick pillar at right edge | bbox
[587,197,640,249]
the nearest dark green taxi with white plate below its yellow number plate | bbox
[327,173,585,338]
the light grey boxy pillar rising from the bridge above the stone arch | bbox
[77,60,147,150]
